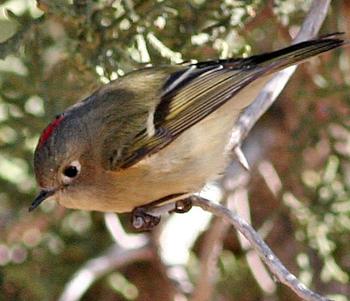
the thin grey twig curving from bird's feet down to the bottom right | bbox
[193,197,330,301]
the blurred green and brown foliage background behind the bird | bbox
[0,0,350,301]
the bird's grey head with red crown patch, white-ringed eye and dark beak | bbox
[29,112,93,211]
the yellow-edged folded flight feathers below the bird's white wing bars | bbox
[115,67,266,168]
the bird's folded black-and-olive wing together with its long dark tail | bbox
[113,36,343,169]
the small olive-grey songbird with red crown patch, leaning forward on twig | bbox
[30,34,344,220]
